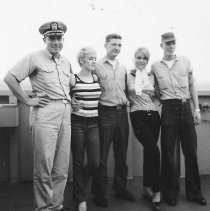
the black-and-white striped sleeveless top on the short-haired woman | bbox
[72,74,101,117]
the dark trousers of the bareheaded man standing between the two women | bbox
[95,106,129,198]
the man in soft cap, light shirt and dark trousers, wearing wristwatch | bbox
[151,32,207,206]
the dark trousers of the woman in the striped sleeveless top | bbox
[70,114,100,204]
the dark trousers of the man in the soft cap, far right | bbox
[161,100,201,199]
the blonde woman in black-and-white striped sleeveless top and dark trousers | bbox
[71,47,101,211]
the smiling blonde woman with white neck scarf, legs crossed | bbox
[127,47,160,210]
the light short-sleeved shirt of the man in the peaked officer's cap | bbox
[9,50,72,100]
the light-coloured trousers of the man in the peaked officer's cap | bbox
[30,102,71,211]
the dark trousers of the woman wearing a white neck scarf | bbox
[130,111,160,192]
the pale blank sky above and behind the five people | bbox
[0,0,210,90]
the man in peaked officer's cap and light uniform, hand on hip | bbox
[4,21,72,211]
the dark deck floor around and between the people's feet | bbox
[0,175,210,211]
